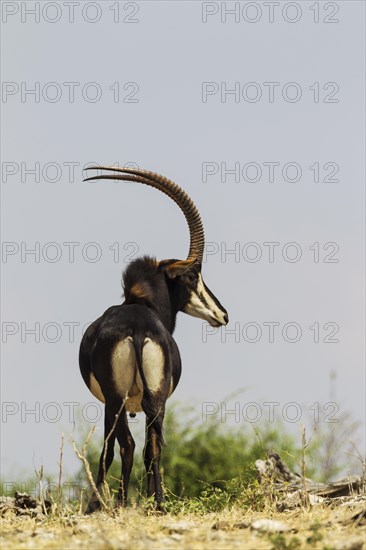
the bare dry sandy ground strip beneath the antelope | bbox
[1,503,366,550]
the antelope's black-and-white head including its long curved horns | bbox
[85,166,229,327]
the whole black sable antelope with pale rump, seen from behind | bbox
[79,166,228,513]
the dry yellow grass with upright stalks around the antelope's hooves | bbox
[0,433,366,550]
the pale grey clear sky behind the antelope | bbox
[1,1,365,479]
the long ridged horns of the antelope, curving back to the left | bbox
[84,166,205,263]
